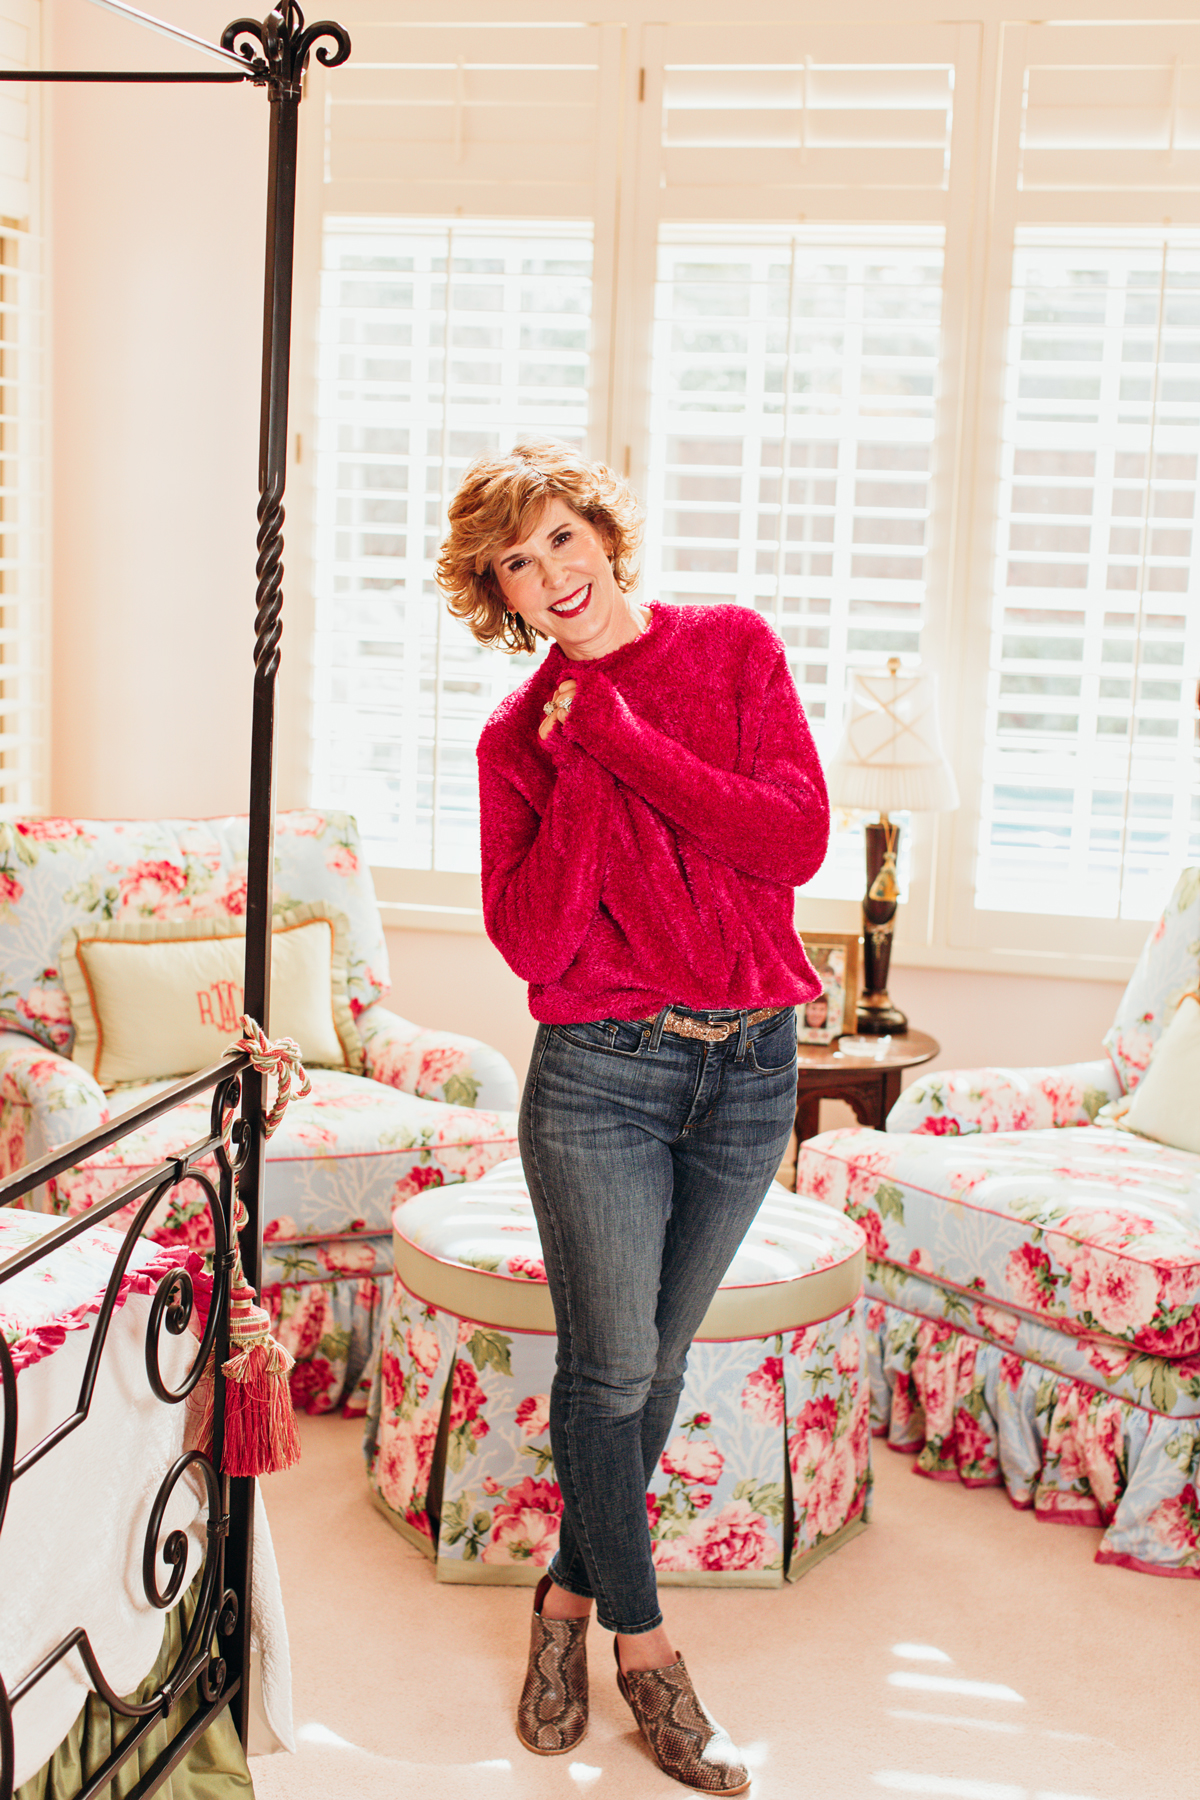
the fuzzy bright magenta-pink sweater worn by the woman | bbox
[479,603,829,1024]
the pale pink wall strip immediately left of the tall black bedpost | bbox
[47,0,268,815]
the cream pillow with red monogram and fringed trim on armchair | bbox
[59,902,363,1087]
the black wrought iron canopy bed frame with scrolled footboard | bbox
[0,0,351,1800]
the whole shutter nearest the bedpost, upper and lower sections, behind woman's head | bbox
[313,16,622,871]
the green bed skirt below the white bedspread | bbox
[13,1577,254,1800]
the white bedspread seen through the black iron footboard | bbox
[0,1213,295,1786]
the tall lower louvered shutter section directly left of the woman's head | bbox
[313,218,592,871]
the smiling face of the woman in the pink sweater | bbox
[491,495,644,662]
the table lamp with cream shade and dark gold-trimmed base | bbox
[826,657,959,1037]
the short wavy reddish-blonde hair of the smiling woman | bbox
[437,437,642,652]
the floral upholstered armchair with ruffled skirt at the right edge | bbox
[797,869,1200,1577]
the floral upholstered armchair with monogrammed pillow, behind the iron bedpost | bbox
[0,812,516,1411]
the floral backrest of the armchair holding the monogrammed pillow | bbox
[0,812,389,1057]
